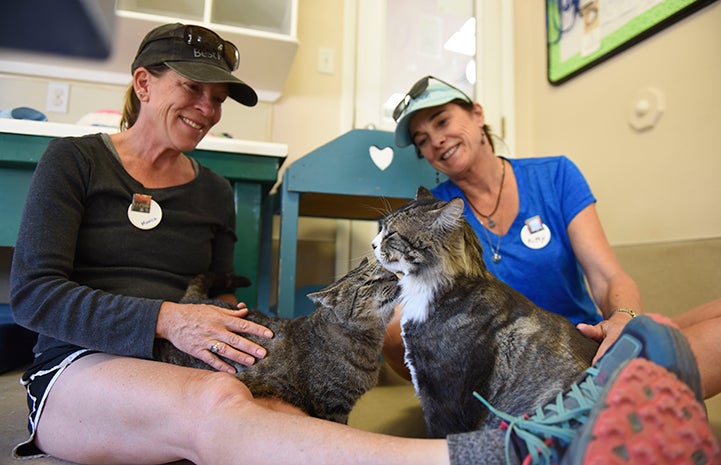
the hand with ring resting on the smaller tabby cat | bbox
[156,302,273,373]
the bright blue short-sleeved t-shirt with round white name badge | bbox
[433,156,602,324]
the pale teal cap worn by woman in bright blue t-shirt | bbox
[393,76,473,147]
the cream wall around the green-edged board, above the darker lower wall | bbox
[514,0,721,245]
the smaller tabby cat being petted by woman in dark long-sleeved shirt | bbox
[154,260,399,423]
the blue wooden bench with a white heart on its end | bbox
[276,129,446,318]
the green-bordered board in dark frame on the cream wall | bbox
[546,0,716,85]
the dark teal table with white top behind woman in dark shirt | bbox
[0,119,287,311]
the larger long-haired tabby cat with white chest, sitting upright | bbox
[373,187,598,437]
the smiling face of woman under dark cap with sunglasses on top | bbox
[138,70,228,152]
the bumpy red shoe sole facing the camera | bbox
[582,358,721,465]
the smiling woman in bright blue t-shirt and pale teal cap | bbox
[390,76,721,397]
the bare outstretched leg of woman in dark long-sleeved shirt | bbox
[36,354,449,465]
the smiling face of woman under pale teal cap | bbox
[408,102,485,178]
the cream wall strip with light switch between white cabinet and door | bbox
[271,0,344,292]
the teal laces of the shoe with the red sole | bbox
[473,367,603,465]
